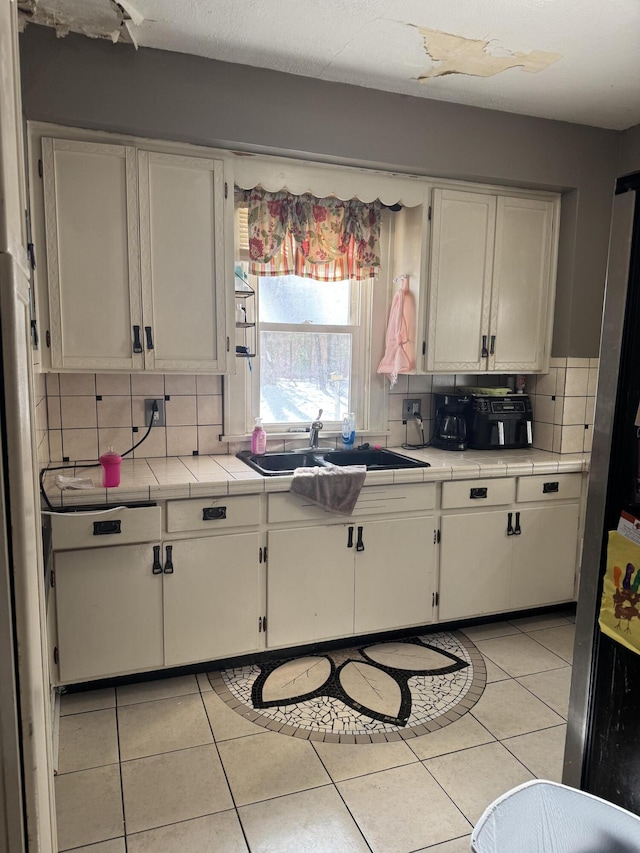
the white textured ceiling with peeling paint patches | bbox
[19,0,640,130]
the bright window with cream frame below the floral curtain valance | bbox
[225,204,390,438]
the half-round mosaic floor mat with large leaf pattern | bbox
[209,631,487,743]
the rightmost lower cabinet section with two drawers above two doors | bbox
[438,474,582,621]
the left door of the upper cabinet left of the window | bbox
[42,139,143,370]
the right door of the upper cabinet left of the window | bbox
[138,151,229,373]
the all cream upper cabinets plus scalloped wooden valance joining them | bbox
[29,123,560,374]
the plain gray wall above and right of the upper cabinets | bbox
[20,25,620,357]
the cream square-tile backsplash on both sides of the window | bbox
[42,358,598,464]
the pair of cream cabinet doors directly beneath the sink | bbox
[267,516,434,646]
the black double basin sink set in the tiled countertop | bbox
[236,448,429,477]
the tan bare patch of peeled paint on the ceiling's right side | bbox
[418,27,562,81]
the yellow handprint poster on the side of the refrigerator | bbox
[599,530,640,654]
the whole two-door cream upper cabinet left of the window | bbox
[40,132,235,373]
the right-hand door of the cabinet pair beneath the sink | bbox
[355,516,434,634]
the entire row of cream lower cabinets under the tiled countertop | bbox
[50,473,582,684]
